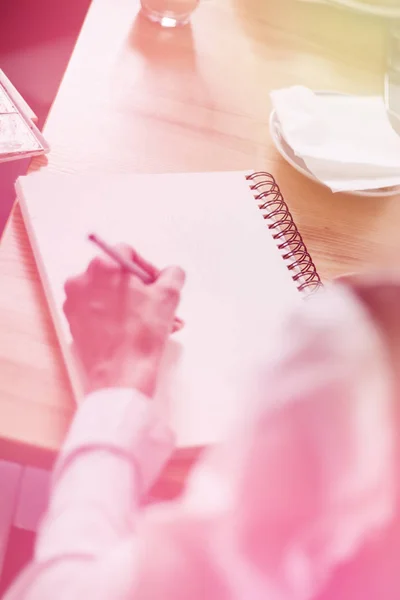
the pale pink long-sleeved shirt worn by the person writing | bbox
[7,288,399,600]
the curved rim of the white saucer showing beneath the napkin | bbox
[269,92,400,198]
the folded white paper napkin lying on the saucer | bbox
[271,86,400,192]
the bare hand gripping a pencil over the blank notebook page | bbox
[64,235,185,397]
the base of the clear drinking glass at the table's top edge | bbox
[141,0,200,27]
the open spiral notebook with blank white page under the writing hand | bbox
[17,172,320,447]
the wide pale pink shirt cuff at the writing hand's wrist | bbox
[57,388,175,493]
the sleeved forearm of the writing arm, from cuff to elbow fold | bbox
[36,389,173,561]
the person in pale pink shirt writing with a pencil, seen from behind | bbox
[6,247,400,600]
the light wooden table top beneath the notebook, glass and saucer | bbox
[0,0,400,466]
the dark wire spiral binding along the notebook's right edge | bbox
[246,172,322,292]
